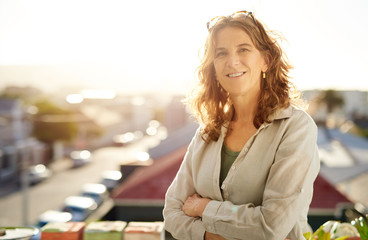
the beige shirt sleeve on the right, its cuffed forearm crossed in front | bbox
[202,112,319,240]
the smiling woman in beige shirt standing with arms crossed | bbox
[164,11,319,240]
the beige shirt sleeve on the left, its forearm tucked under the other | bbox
[163,130,205,240]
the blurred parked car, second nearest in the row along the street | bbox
[62,196,97,222]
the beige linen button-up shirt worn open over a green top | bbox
[163,106,320,240]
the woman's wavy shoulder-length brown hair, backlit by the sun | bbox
[187,11,299,142]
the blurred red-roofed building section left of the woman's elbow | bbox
[105,145,187,221]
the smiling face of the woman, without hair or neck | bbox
[214,27,267,96]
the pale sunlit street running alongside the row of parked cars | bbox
[0,136,159,226]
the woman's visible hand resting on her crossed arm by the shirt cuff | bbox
[182,193,211,217]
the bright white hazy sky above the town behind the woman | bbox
[0,0,368,92]
